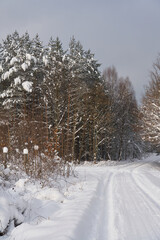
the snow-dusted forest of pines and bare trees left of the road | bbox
[0,32,142,167]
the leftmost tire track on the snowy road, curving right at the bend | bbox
[92,162,155,240]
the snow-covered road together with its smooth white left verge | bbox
[1,156,160,240]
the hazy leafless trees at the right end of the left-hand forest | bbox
[103,67,141,160]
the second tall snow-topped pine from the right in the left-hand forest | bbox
[43,38,68,157]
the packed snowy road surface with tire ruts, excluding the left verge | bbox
[93,164,160,240]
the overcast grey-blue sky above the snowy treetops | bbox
[0,0,160,102]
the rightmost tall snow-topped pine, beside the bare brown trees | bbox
[66,37,99,160]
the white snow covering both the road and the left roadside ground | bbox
[0,155,160,240]
